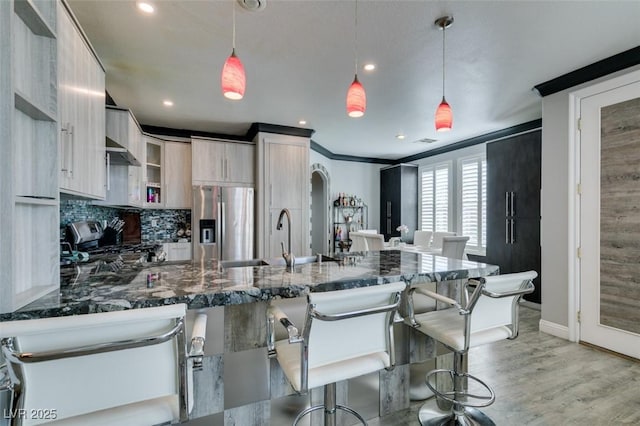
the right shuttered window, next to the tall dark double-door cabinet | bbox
[458,155,487,252]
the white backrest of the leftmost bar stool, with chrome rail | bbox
[0,304,188,424]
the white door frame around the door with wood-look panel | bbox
[567,70,640,342]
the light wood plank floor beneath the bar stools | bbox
[369,307,640,426]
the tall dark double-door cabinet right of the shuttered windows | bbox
[486,130,541,303]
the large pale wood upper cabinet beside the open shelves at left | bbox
[58,3,106,199]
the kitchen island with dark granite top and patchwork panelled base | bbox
[0,250,498,425]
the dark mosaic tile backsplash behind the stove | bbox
[60,199,191,243]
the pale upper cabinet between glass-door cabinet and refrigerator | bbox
[163,141,192,209]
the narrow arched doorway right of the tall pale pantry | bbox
[310,163,331,254]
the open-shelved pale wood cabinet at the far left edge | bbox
[0,0,60,313]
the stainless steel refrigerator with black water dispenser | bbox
[191,186,255,260]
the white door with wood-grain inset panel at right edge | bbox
[580,81,640,358]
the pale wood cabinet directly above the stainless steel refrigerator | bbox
[191,137,255,186]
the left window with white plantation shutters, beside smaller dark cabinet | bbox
[420,162,451,231]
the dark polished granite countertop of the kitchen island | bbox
[0,250,498,321]
